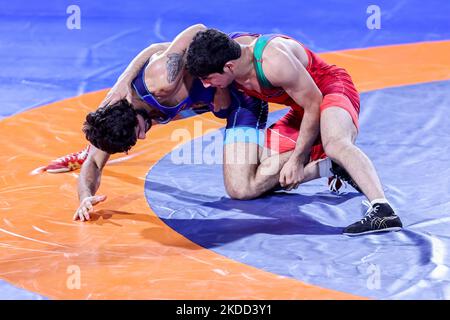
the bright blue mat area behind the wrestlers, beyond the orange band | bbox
[0,0,450,117]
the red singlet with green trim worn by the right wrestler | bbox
[231,33,360,161]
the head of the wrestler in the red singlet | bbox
[187,29,241,88]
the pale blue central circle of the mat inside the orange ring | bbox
[145,81,450,299]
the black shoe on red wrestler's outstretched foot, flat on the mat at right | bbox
[343,203,403,236]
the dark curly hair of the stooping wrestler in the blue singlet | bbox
[83,100,138,154]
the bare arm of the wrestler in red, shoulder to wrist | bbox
[264,48,322,163]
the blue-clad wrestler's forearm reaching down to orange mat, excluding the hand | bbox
[78,146,110,202]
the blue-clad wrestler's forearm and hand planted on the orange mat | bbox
[73,146,110,221]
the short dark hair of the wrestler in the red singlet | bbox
[187,29,241,78]
